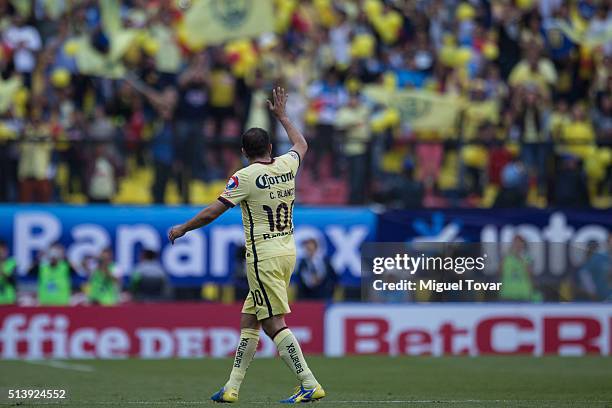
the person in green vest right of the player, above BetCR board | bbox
[499,235,541,302]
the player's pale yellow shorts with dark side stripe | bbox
[242,255,295,320]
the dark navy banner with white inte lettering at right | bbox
[376,209,612,277]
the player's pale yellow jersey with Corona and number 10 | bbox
[219,150,300,263]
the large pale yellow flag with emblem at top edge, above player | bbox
[184,0,274,44]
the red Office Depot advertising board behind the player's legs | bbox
[0,303,324,359]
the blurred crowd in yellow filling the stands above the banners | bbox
[0,0,612,208]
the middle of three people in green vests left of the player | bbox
[38,244,72,306]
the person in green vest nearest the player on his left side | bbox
[88,248,120,306]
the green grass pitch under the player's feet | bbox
[0,356,612,408]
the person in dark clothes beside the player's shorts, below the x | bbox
[296,238,338,300]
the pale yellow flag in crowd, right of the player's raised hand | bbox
[364,86,461,131]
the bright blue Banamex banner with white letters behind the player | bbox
[0,205,376,285]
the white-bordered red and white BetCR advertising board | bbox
[325,303,612,356]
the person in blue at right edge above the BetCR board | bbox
[578,237,612,301]
